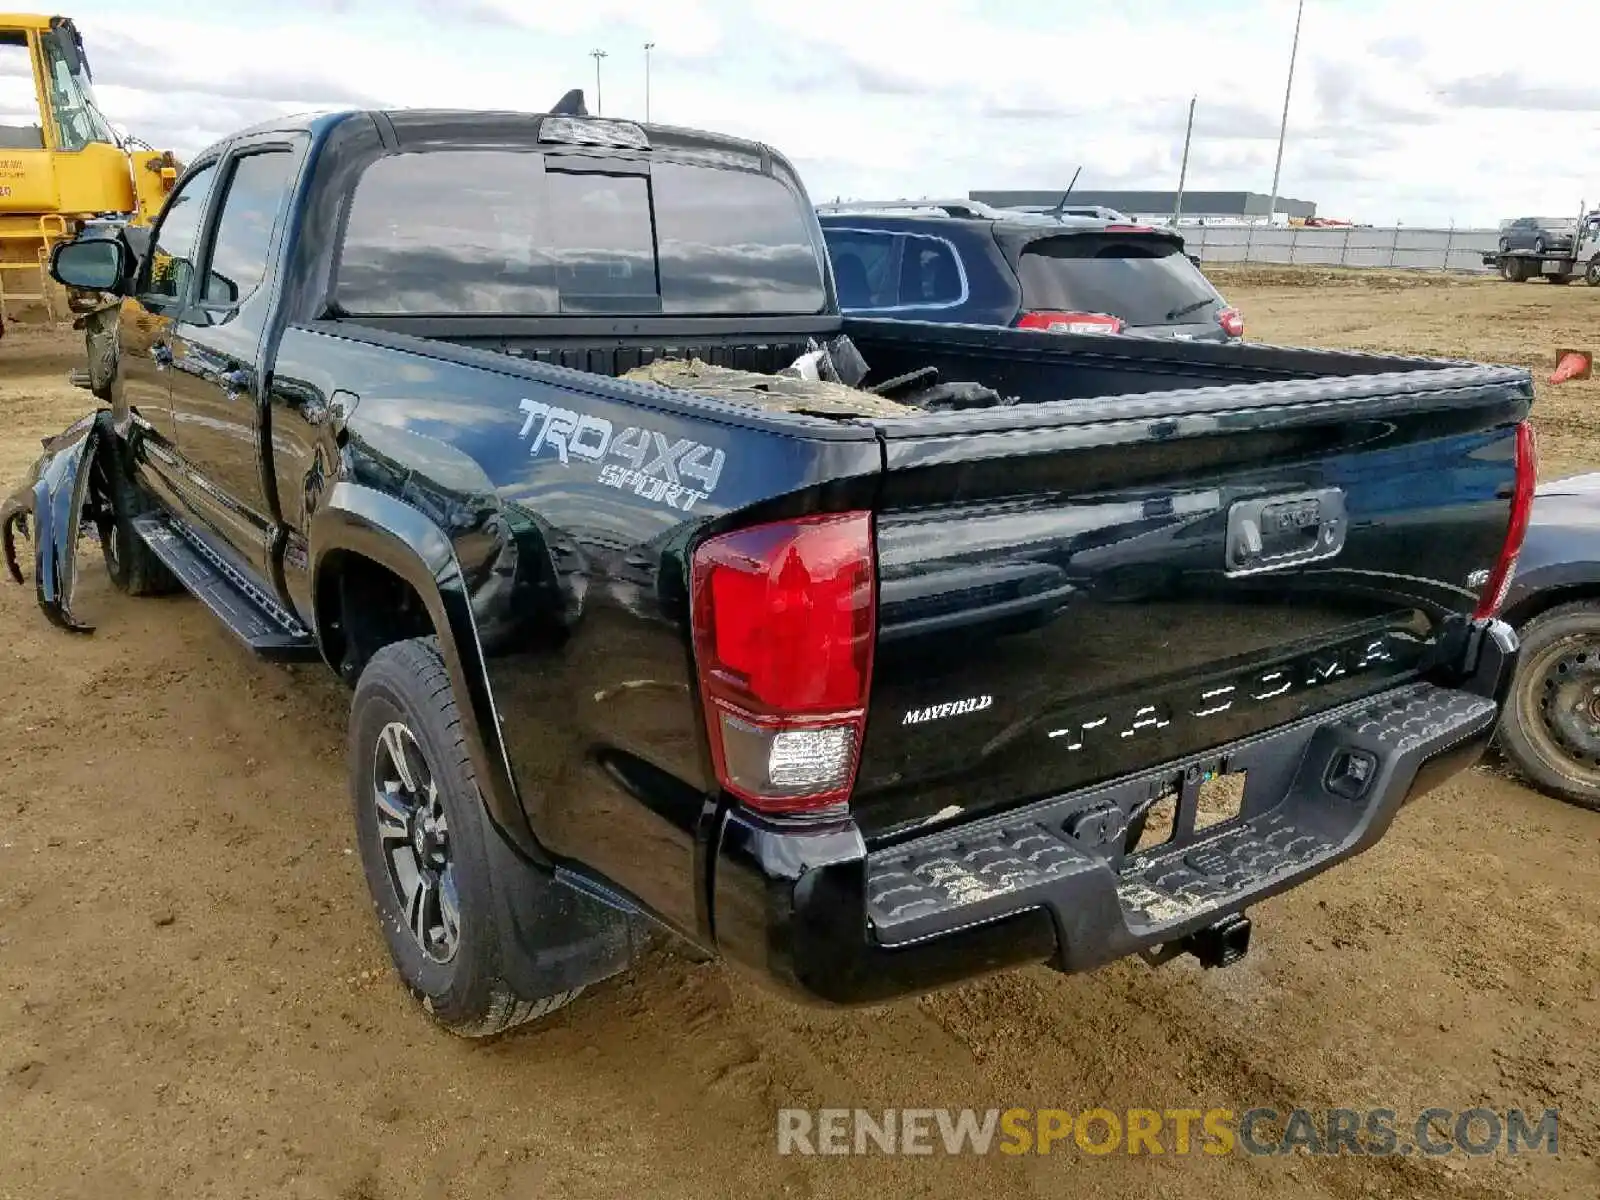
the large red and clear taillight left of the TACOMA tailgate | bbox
[691,512,877,813]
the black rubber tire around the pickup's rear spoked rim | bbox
[349,637,582,1037]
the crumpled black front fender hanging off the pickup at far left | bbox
[0,410,110,634]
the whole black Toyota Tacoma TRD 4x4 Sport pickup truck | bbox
[0,112,1533,1034]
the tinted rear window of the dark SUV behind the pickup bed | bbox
[1018,234,1222,325]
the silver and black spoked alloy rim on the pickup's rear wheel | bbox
[373,722,461,963]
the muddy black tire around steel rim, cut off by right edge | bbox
[1496,600,1600,811]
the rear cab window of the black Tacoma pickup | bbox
[345,150,826,315]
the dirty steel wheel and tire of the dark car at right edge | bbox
[1498,602,1600,811]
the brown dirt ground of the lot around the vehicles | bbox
[0,270,1600,1200]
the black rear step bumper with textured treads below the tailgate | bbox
[712,621,1517,1003]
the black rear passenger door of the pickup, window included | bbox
[170,139,299,578]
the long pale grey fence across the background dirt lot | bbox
[1179,226,1499,272]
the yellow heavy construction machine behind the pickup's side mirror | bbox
[0,13,179,334]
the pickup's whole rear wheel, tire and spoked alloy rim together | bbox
[349,638,582,1037]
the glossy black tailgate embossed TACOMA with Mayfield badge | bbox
[851,366,1531,843]
